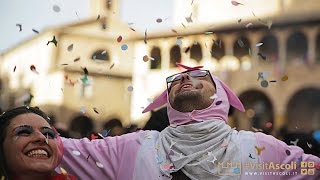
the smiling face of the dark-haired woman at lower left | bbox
[3,113,58,174]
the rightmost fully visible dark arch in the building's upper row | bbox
[287,31,308,62]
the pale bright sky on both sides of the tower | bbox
[0,0,172,53]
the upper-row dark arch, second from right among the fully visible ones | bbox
[259,34,279,62]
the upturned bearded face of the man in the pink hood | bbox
[169,70,216,112]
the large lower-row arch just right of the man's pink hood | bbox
[235,89,274,134]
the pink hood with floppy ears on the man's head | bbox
[143,64,245,125]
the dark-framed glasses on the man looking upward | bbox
[166,69,213,92]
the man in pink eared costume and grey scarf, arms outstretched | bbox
[61,64,320,180]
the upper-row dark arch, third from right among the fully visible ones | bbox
[233,36,251,60]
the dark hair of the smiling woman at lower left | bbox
[0,106,50,179]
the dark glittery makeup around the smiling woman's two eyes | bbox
[14,125,57,139]
